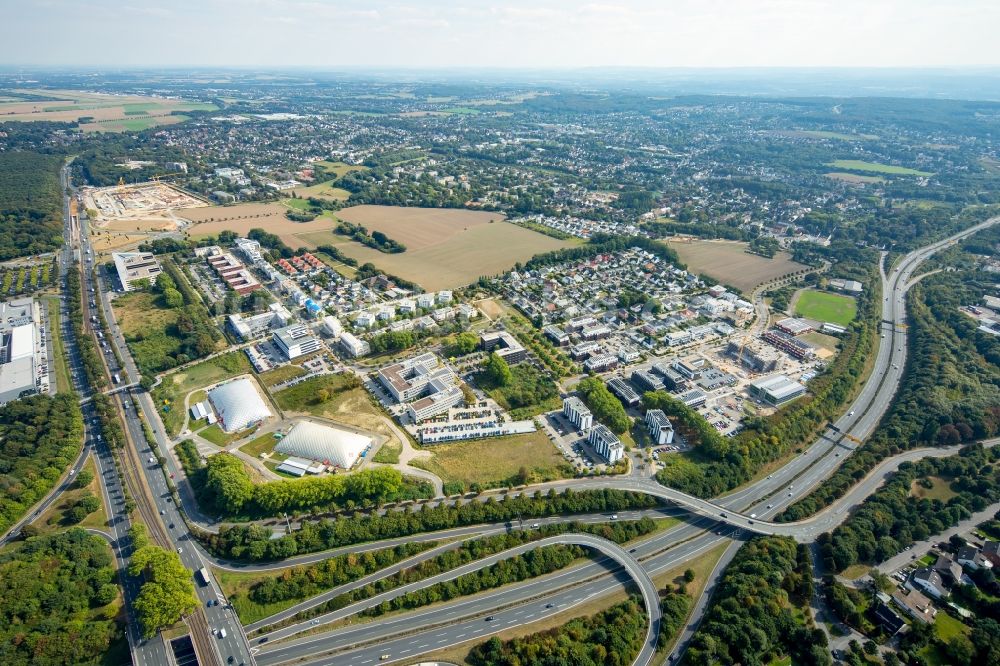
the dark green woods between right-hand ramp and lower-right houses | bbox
[820,445,1000,572]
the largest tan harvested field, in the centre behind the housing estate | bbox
[293,206,573,291]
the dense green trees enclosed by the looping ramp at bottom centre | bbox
[468,598,646,666]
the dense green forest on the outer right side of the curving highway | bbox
[778,264,1000,520]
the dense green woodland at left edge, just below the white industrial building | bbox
[0,393,83,531]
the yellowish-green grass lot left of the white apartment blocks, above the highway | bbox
[411,431,573,488]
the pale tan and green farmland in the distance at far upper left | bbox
[0,90,216,132]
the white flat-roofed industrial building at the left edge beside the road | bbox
[0,298,50,404]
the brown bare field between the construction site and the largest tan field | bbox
[186,203,337,248]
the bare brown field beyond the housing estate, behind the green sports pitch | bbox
[667,240,806,294]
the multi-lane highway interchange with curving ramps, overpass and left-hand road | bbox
[46,162,1000,666]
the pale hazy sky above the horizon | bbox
[0,0,1000,68]
